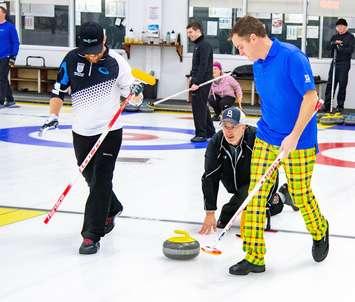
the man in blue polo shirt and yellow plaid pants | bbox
[229,16,329,275]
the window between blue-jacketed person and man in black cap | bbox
[20,0,69,46]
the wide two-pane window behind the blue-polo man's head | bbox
[188,0,303,54]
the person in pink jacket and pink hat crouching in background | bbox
[208,61,243,121]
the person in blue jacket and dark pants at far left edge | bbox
[0,6,20,108]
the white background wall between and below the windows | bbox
[17,0,355,109]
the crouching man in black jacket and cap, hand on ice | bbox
[199,107,298,234]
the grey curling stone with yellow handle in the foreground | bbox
[163,230,200,260]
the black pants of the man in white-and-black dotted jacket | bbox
[73,129,122,242]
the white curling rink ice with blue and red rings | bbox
[0,104,355,302]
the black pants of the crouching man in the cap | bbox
[218,176,279,224]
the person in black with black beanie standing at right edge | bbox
[323,19,355,112]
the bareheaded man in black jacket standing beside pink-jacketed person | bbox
[186,22,215,143]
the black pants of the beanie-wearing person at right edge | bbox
[324,61,350,111]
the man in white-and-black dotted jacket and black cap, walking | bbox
[42,22,143,254]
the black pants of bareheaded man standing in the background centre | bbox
[191,85,215,137]
